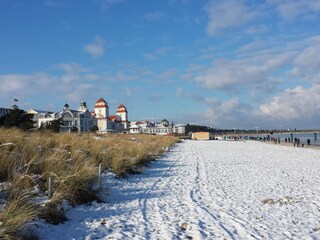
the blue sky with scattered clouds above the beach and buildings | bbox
[0,0,320,129]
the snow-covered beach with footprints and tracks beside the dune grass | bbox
[37,141,320,239]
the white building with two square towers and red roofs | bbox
[94,98,129,133]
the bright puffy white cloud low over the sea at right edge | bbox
[260,84,320,122]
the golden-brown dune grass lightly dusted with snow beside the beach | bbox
[0,128,178,239]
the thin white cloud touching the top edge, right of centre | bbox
[205,0,259,35]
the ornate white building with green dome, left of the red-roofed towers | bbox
[37,101,97,132]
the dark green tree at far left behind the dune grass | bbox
[0,108,34,130]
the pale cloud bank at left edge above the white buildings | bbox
[0,63,93,107]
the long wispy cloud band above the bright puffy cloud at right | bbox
[194,36,320,94]
